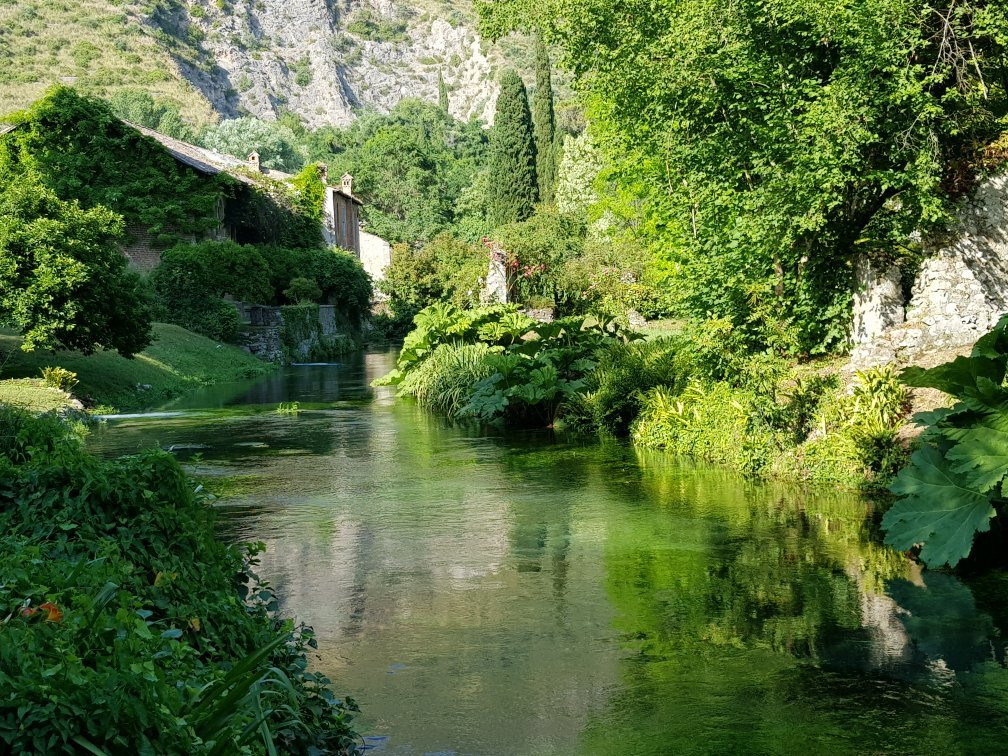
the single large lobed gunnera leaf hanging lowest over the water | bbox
[882,447,995,566]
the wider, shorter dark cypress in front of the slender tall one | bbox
[488,71,539,226]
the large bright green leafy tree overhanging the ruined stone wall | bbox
[481,0,1008,352]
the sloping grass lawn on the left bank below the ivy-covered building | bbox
[0,323,273,410]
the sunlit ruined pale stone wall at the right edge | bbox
[851,172,1008,368]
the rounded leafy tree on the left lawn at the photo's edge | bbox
[0,174,150,357]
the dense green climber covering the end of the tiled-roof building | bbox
[0,87,228,238]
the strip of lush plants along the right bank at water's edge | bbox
[380,304,909,487]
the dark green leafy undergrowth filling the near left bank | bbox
[0,407,357,754]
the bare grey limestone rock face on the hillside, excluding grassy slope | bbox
[172,0,500,127]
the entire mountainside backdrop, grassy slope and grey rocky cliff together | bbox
[0,0,531,126]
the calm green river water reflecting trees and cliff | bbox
[86,352,1008,754]
